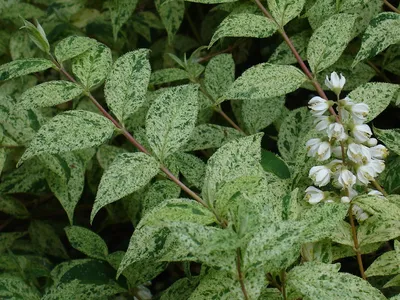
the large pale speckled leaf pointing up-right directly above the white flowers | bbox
[307,14,357,74]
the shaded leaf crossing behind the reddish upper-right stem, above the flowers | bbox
[268,30,312,65]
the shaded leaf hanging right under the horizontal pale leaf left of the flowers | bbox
[241,97,285,134]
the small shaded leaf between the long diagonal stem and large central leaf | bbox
[174,153,206,189]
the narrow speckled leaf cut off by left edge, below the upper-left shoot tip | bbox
[0,58,54,81]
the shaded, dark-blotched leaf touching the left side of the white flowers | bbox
[278,107,314,162]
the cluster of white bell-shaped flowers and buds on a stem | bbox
[306,72,388,210]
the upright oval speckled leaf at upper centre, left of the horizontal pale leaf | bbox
[204,54,235,100]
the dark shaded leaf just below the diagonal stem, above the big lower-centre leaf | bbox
[142,180,181,215]
